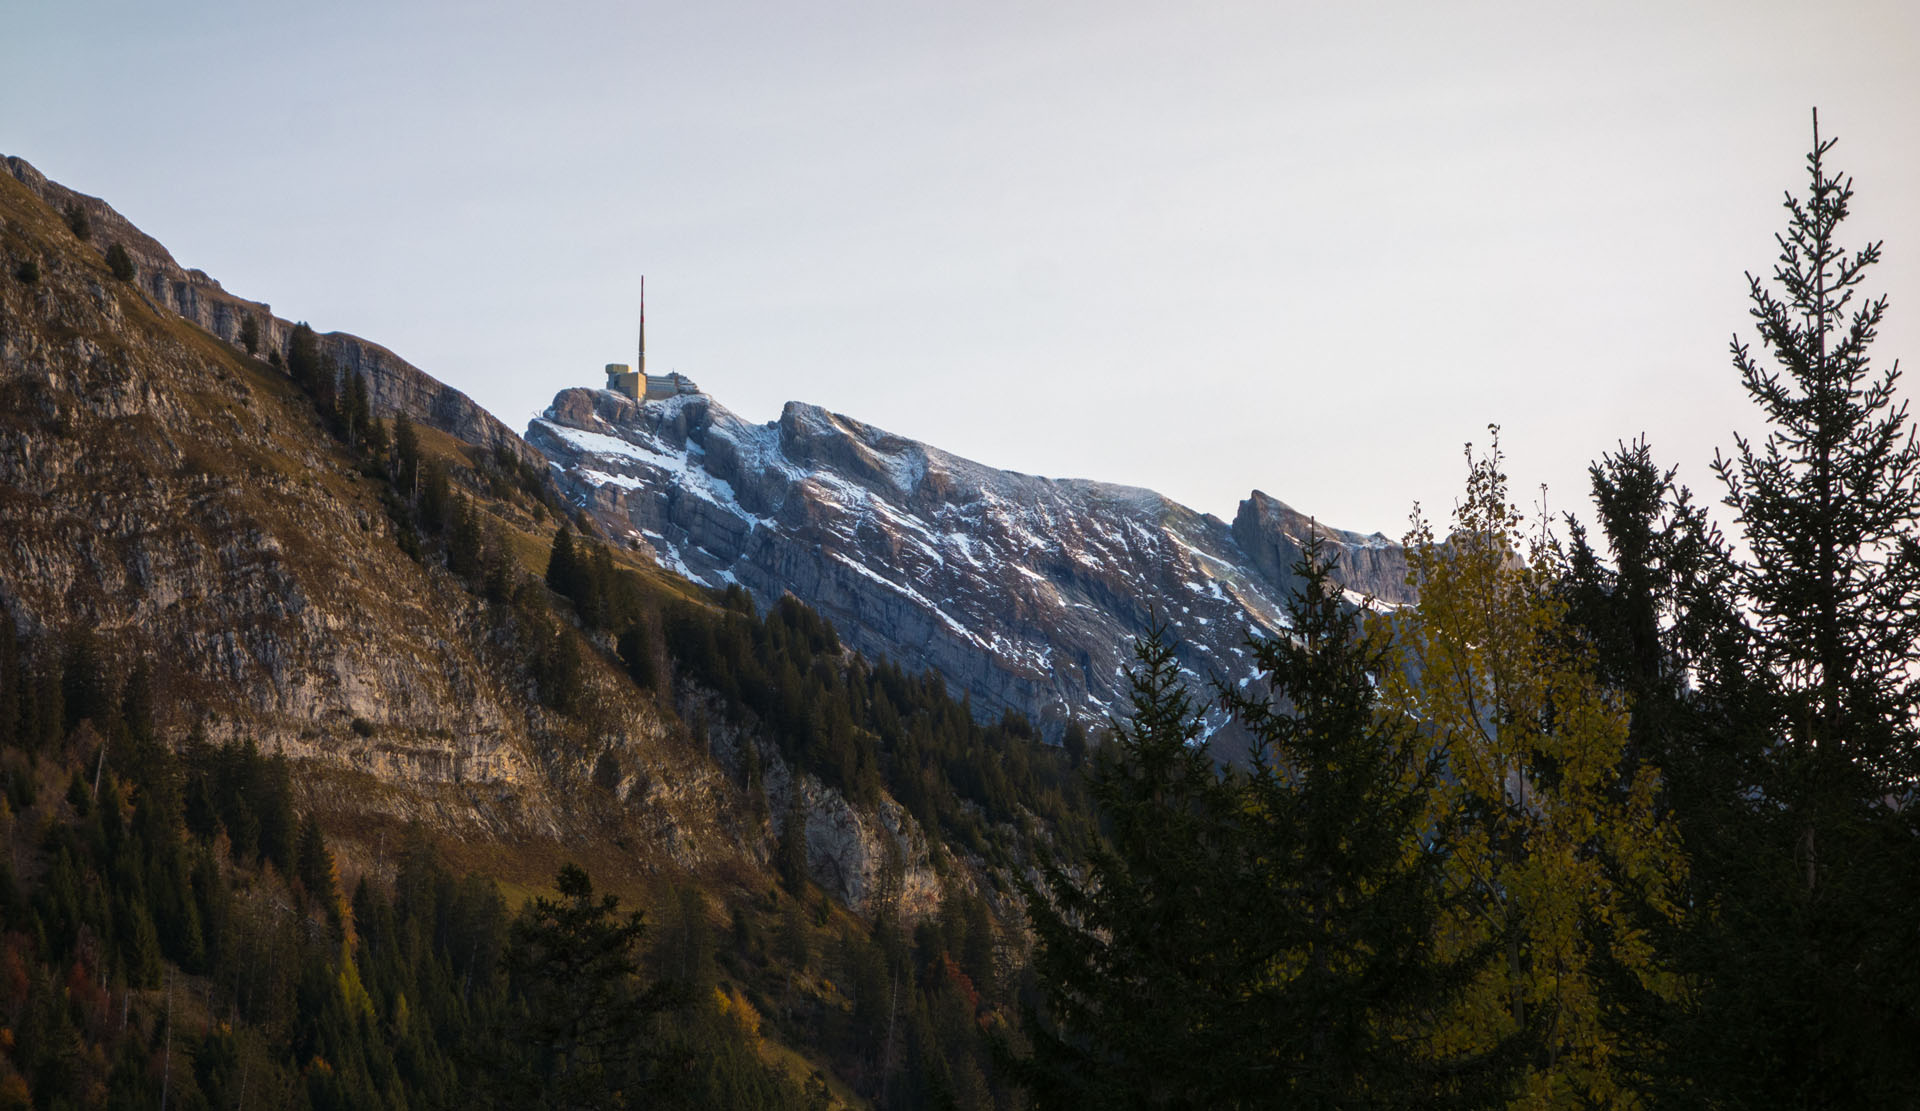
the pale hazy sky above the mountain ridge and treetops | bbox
[0,0,1920,537]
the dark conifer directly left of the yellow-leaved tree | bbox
[1221,532,1515,1107]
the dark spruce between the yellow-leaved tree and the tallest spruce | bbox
[1557,441,1763,1105]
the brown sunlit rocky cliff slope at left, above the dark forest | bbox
[0,163,610,833]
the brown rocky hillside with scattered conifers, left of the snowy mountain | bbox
[0,159,1083,1105]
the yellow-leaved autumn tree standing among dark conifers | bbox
[1386,430,1686,1109]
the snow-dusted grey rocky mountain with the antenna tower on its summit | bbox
[526,381,1411,756]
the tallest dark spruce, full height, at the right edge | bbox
[1686,117,1920,1105]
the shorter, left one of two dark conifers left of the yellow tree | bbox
[1014,626,1258,1109]
